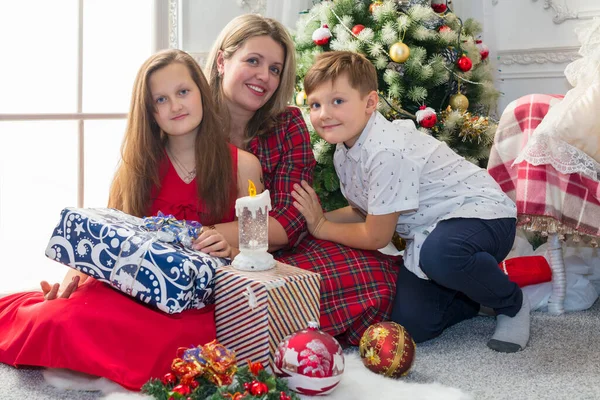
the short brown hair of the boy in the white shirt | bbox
[304,51,378,96]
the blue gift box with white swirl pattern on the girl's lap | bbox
[46,208,229,314]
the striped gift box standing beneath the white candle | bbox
[215,262,320,366]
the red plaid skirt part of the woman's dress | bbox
[275,235,402,345]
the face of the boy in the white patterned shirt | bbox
[308,75,377,147]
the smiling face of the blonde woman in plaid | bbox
[217,36,284,113]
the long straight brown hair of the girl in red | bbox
[108,49,236,224]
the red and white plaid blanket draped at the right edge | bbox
[488,94,600,236]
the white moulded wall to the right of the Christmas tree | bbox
[454,0,600,112]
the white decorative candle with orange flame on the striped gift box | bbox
[231,180,276,271]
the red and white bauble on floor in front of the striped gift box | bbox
[273,322,344,396]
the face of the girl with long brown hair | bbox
[149,62,203,136]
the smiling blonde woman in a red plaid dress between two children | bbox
[206,14,398,345]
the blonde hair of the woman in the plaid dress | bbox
[205,14,296,142]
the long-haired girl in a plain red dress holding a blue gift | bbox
[0,50,262,390]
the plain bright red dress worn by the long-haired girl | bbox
[0,146,237,390]
